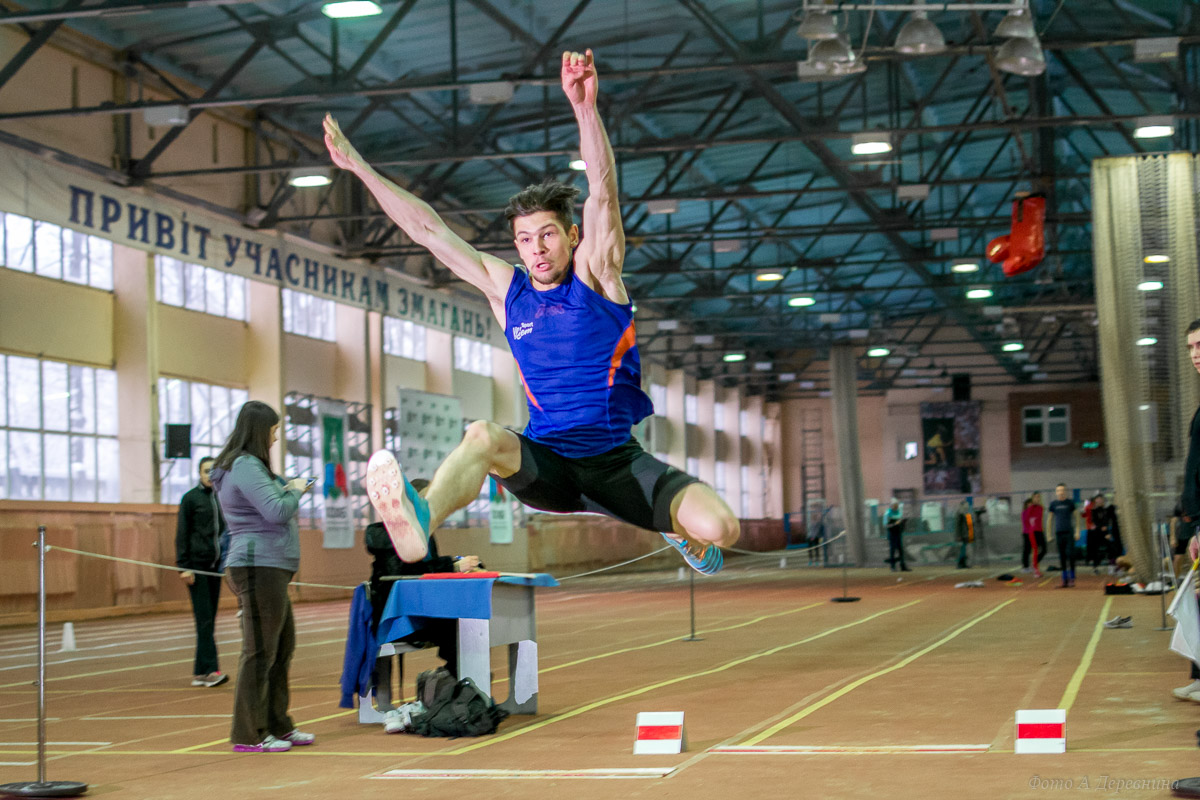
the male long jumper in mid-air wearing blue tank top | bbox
[325,50,739,575]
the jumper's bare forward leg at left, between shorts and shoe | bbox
[425,420,521,530]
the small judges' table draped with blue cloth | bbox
[377,572,558,714]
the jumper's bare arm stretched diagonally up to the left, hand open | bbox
[325,114,512,316]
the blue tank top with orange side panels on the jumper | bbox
[504,267,654,458]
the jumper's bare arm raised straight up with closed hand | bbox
[563,50,628,302]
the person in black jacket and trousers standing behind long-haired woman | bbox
[175,456,229,686]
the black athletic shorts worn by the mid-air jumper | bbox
[497,433,700,533]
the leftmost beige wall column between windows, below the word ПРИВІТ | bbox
[112,245,162,503]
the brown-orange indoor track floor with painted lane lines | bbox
[0,563,1200,800]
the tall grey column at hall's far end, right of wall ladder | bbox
[829,345,866,565]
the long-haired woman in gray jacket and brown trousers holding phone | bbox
[212,401,314,753]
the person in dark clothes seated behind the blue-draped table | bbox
[365,480,480,712]
